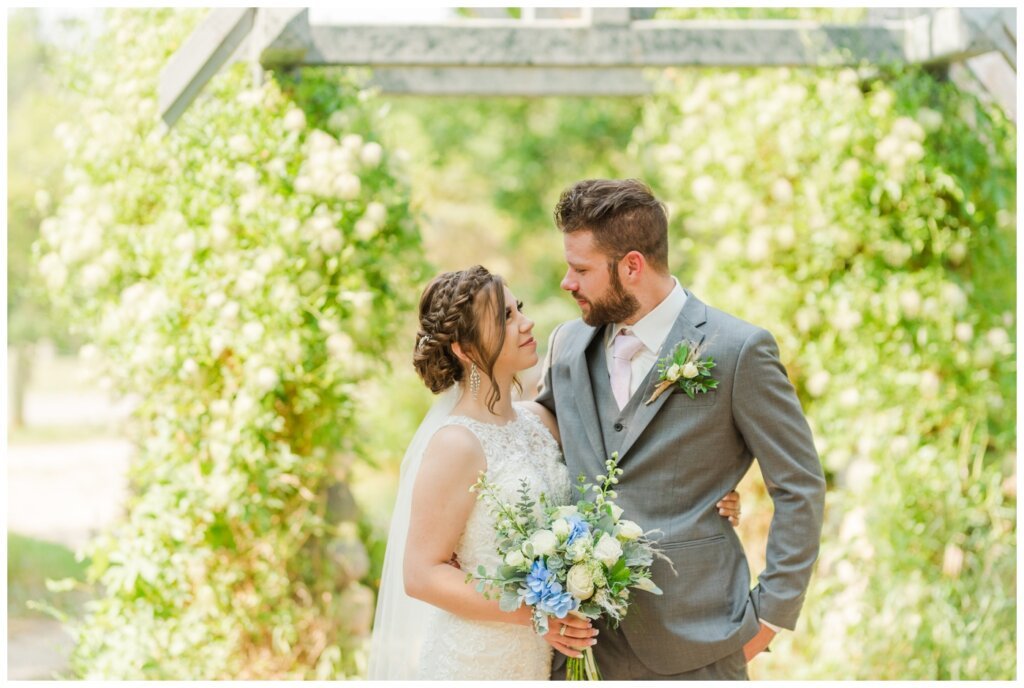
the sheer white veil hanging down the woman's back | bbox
[368,385,462,681]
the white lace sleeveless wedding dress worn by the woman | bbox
[417,404,571,681]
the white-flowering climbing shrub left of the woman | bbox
[36,10,423,679]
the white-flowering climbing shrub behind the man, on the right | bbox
[633,70,1016,680]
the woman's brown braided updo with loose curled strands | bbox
[413,265,505,412]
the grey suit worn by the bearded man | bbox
[537,292,825,679]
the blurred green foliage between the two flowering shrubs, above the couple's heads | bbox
[385,97,643,333]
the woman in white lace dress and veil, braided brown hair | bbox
[368,265,738,680]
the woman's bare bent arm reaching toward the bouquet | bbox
[403,426,529,626]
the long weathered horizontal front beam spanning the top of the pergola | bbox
[284,20,904,68]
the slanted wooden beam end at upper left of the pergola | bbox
[157,7,255,127]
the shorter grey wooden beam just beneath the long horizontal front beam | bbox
[372,67,654,96]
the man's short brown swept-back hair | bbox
[555,179,669,272]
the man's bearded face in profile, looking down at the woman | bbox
[561,230,640,328]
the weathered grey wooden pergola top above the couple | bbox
[159,7,1017,126]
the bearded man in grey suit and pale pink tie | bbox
[537,179,825,680]
